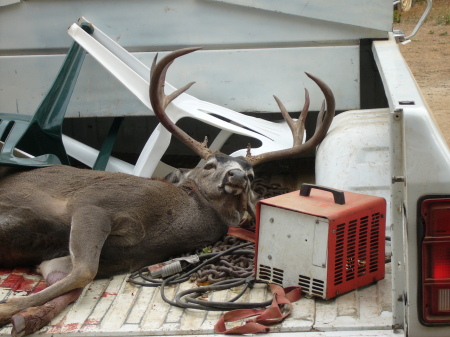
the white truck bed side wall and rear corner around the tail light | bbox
[372,36,450,337]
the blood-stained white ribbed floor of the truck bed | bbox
[0,265,399,337]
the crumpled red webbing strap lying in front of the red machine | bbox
[214,284,301,334]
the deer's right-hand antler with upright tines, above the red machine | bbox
[245,73,335,165]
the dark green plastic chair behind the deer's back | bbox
[0,23,122,170]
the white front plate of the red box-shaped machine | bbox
[256,205,329,297]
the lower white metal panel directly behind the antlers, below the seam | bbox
[0,45,359,117]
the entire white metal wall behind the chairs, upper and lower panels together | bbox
[0,0,364,117]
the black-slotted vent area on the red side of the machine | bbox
[334,213,381,286]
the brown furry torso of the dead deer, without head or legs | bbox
[0,166,244,277]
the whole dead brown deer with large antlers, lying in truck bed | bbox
[0,48,335,336]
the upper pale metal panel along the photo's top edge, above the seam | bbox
[0,0,386,54]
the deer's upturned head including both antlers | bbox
[149,47,335,218]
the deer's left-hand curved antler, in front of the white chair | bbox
[149,47,212,159]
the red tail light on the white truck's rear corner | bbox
[421,198,450,324]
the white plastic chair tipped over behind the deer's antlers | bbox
[60,18,293,177]
